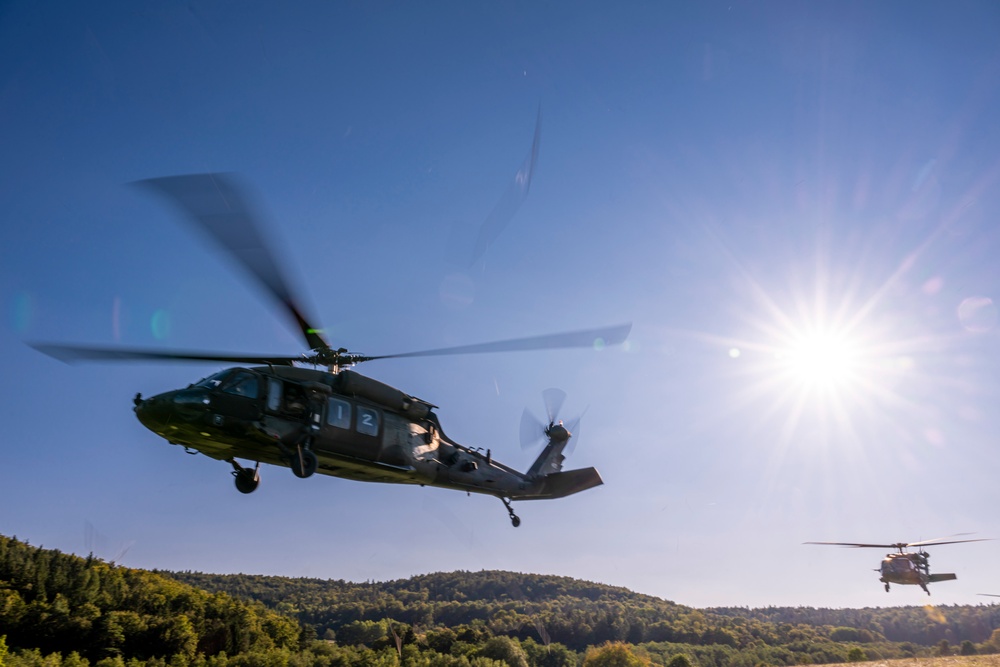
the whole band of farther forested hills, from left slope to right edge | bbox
[170,571,1000,664]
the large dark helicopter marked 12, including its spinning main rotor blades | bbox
[32,174,631,528]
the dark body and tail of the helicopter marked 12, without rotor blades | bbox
[135,365,602,508]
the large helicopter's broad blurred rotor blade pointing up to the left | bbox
[136,174,330,350]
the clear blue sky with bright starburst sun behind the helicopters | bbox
[0,0,1000,607]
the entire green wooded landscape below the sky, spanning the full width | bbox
[0,536,1000,667]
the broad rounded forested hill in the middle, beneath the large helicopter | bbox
[164,571,696,648]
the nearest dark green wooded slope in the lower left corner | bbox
[0,535,300,664]
